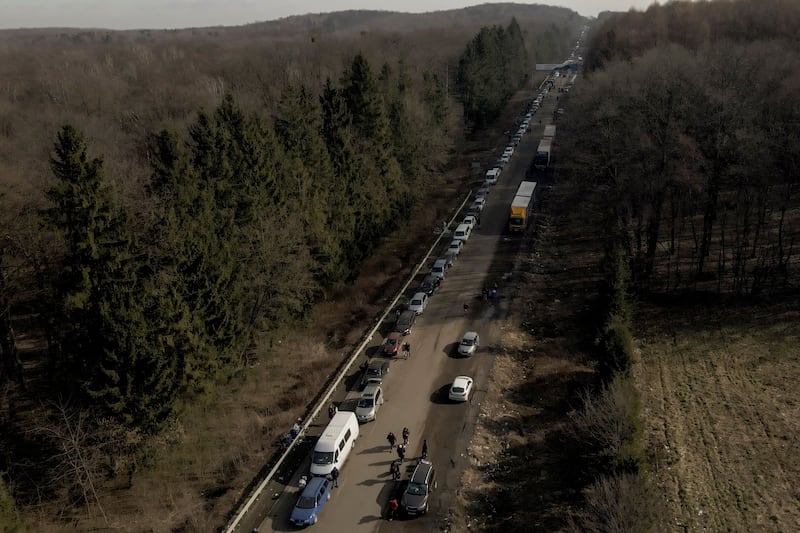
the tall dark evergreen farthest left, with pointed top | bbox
[46,126,178,430]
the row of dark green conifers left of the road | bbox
[4,54,447,432]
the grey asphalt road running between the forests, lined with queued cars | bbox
[238,78,556,533]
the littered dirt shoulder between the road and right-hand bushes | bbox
[451,163,601,532]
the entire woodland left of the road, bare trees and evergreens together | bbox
[0,5,582,527]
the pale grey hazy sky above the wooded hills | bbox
[0,0,655,30]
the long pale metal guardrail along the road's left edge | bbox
[225,190,472,533]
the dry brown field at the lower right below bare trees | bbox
[636,299,800,532]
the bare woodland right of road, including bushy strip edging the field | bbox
[559,0,800,532]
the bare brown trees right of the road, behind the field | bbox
[568,0,800,295]
